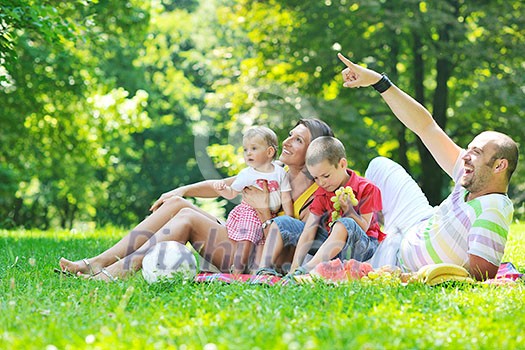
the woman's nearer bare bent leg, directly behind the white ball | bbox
[90,208,235,279]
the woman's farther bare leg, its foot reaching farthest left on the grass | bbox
[59,197,216,273]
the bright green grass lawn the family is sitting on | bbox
[0,224,525,349]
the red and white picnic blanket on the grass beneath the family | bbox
[195,262,525,286]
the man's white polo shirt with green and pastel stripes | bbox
[399,156,514,271]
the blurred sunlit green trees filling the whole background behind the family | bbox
[0,0,525,229]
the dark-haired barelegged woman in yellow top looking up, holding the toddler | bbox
[60,119,333,280]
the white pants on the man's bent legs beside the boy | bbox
[365,157,434,268]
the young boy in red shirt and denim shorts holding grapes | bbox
[290,136,385,274]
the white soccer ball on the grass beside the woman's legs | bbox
[142,241,197,283]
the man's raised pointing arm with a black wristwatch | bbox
[338,54,461,176]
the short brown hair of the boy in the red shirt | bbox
[306,136,346,168]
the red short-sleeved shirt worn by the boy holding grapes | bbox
[310,169,386,242]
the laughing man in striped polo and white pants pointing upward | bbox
[338,54,518,280]
